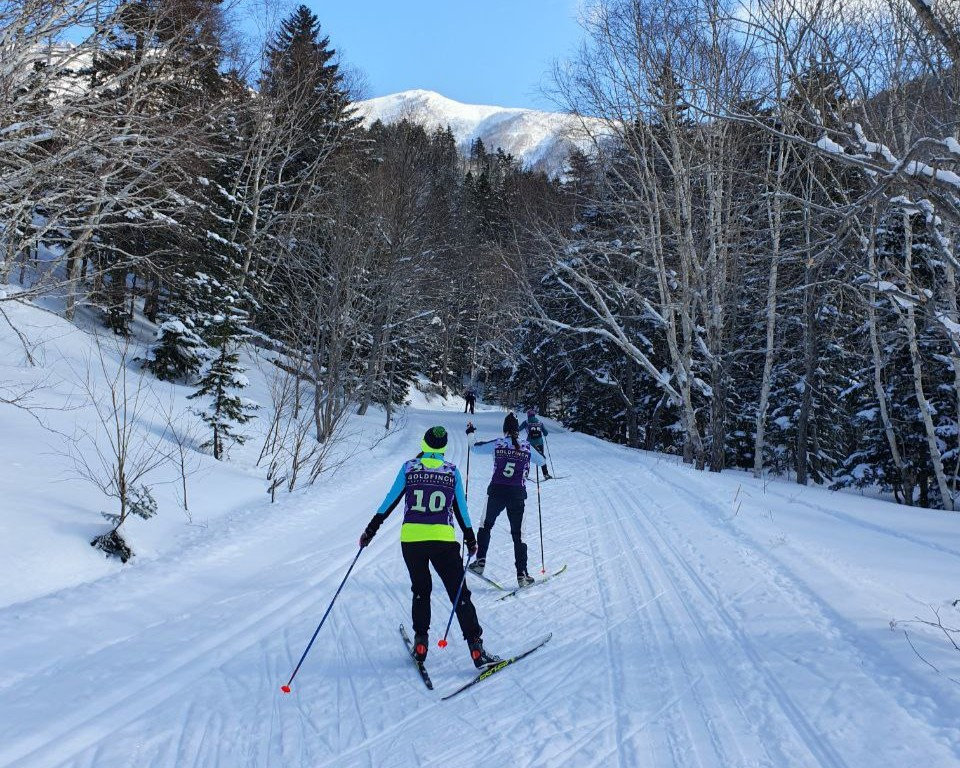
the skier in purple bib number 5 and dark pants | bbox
[468,411,546,587]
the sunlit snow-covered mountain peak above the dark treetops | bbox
[357,90,590,175]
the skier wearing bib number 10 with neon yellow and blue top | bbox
[360,427,500,669]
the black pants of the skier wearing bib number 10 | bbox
[400,541,483,640]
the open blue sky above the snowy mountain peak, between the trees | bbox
[303,0,581,109]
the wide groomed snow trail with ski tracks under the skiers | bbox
[0,410,960,768]
